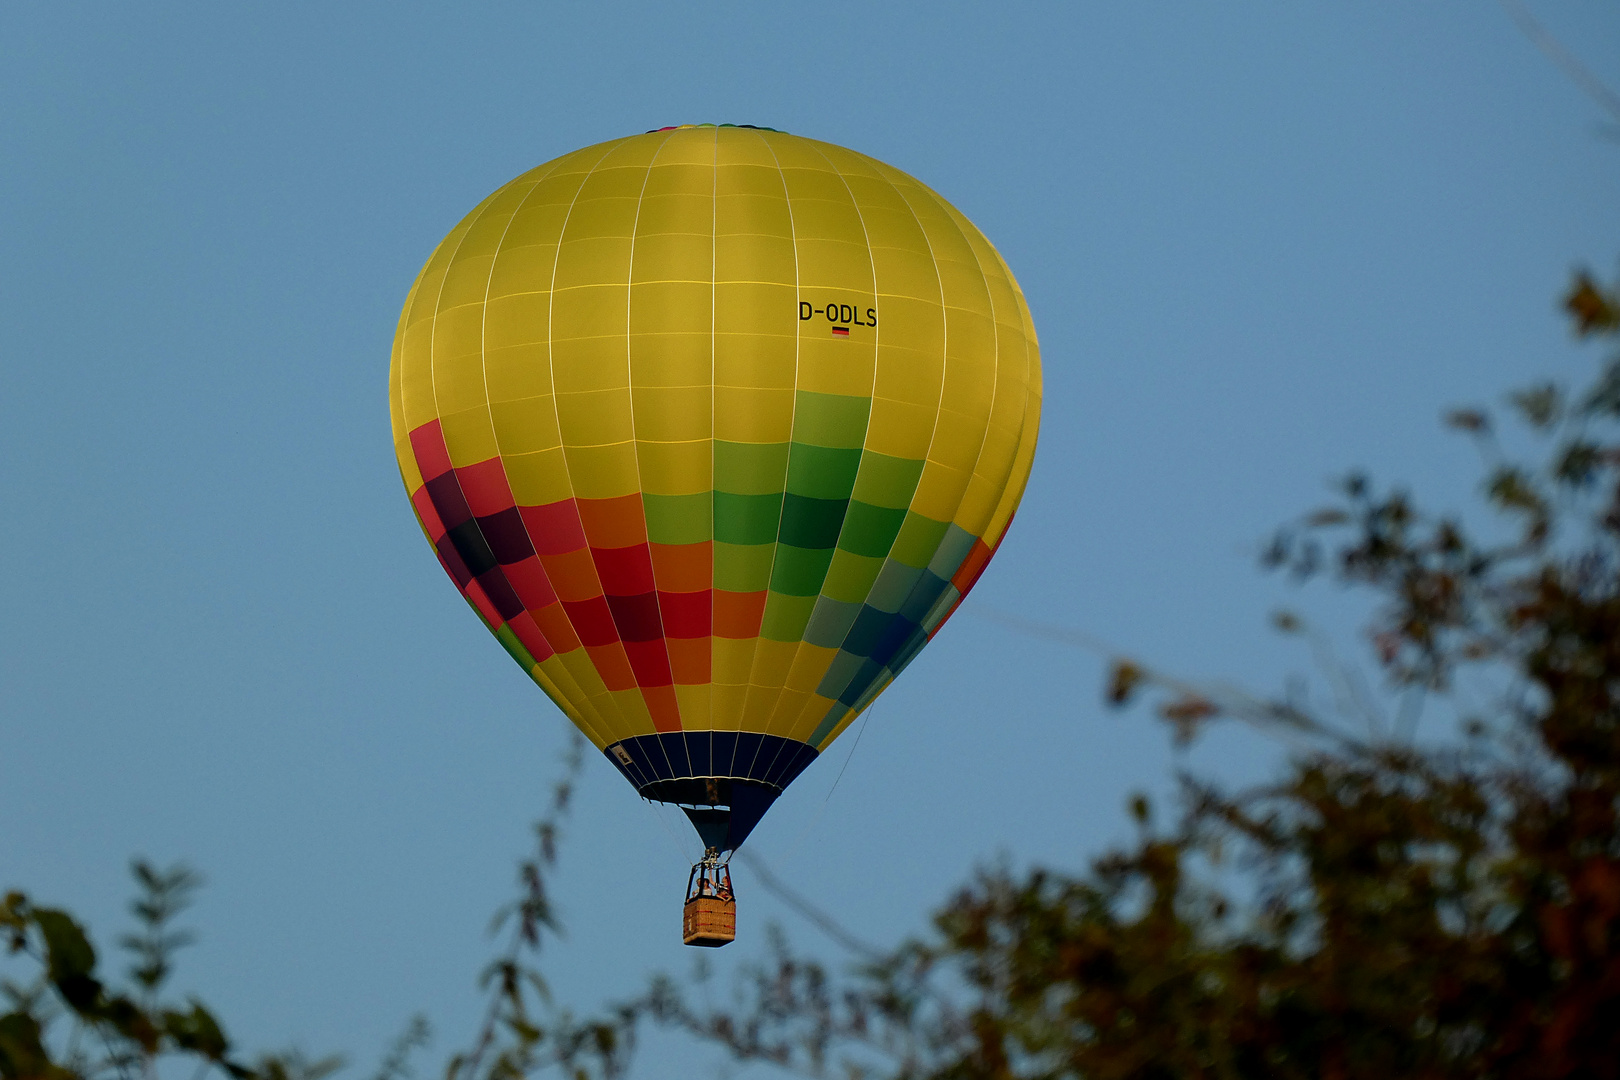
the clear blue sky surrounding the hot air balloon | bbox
[0,0,1620,1077]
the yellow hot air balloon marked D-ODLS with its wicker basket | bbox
[389,125,1040,944]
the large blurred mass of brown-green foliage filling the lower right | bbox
[645,274,1620,1080]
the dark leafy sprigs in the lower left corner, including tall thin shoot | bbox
[0,733,637,1080]
